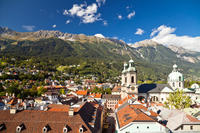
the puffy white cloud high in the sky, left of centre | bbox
[63,3,101,24]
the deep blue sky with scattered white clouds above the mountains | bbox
[0,0,200,51]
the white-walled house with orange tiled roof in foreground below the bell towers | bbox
[115,99,170,133]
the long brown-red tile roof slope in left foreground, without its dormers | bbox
[0,110,91,133]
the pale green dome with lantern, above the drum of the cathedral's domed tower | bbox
[168,64,184,82]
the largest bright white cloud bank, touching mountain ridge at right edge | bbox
[150,25,200,52]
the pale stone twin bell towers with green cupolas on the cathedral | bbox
[121,59,138,98]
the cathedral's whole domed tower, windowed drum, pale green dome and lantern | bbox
[168,64,184,90]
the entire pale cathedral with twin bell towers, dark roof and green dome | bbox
[119,59,200,103]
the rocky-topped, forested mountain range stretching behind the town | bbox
[0,27,200,80]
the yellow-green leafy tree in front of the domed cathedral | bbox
[164,89,192,109]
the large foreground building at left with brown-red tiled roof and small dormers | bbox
[0,102,103,133]
